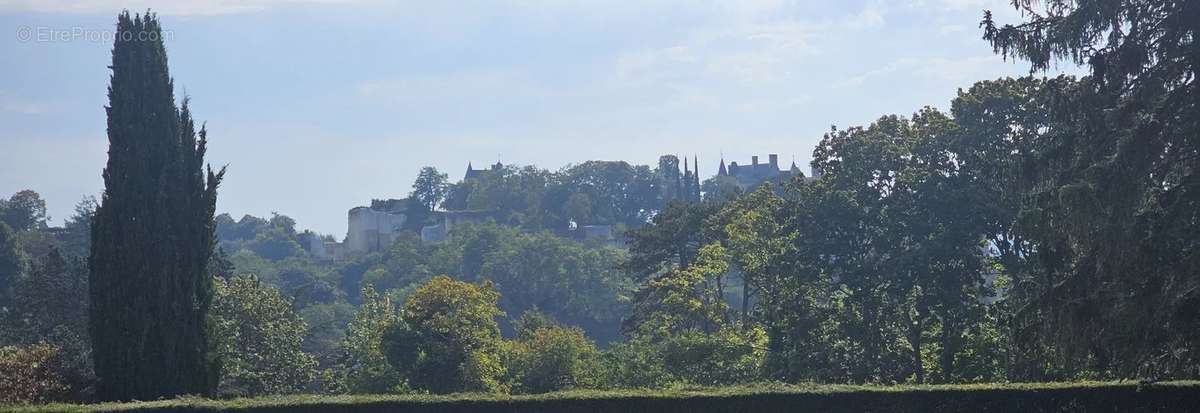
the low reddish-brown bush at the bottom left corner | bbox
[0,343,72,405]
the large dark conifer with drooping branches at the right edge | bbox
[983,0,1200,377]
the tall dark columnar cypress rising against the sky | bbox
[89,11,224,400]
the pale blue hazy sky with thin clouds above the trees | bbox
[0,0,1079,237]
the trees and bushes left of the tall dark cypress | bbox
[0,190,95,402]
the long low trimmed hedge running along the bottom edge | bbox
[0,382,1200,413]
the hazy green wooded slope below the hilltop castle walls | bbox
[214,215,634,360]
